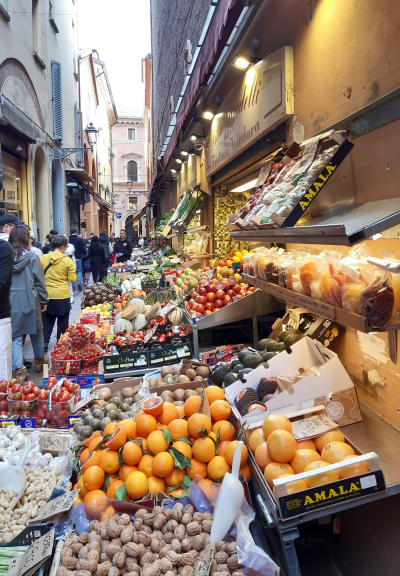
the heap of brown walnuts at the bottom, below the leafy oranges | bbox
[56,503,243,576]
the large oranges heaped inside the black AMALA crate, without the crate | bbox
[248,414,369,494]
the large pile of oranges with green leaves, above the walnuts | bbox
[74,386,251,517]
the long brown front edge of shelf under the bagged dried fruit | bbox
[242,274,400,333]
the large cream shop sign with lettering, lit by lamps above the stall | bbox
[205,46,294,177]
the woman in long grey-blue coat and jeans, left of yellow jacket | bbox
[9,225,49,382]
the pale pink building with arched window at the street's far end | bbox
[112,107,148,238]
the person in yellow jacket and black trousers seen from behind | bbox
[40,234,77,352]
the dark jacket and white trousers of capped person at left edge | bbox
[0,239,13,380]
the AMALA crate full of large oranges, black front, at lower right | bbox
[245,407,386,520]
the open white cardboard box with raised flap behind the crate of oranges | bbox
[225,337,361,424]
